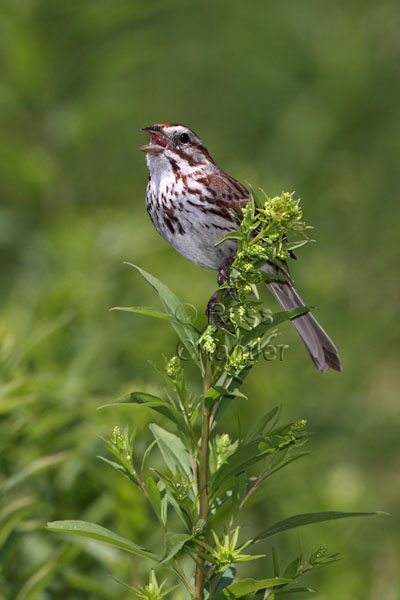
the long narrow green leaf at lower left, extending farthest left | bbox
[47,521,158,562]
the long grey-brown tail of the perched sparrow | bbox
[263,263,343,373]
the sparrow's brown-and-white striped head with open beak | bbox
[139,123,214,171]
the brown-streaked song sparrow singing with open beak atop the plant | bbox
[140,123,342,373]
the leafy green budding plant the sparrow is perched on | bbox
[48,194,380,600]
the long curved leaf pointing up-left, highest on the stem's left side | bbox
[126,262,200,366]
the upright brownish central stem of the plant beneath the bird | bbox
[194,360,211,600]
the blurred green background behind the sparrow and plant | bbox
[0,0,400,600]
